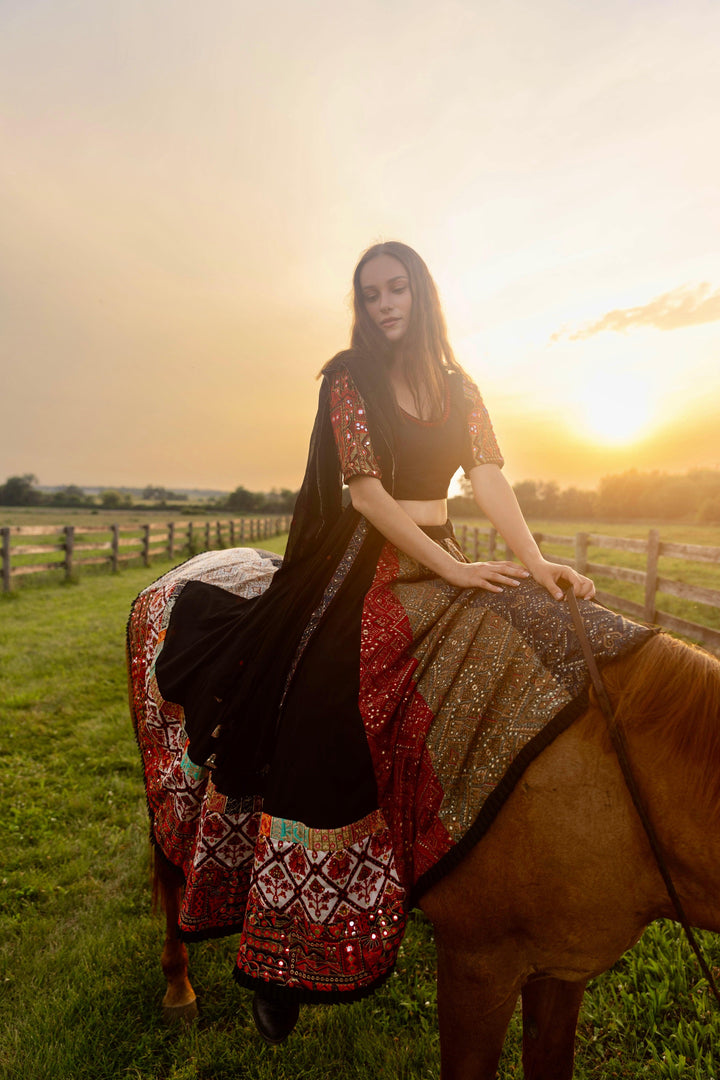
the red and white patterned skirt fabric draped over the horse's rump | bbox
[127,549,279,936]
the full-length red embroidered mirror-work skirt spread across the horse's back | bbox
[128,518,651,1001]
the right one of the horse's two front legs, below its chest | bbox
[522,977,586,1080]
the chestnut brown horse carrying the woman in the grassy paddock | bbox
[132,553,720,1080]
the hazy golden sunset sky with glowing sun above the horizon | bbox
[0,0,720,490]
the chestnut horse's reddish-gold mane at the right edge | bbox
[590,634,720,812]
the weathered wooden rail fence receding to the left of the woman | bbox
[0,516,290,592]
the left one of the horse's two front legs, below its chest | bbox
[437,941,519,1080]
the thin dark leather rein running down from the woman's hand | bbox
[565,586,720,1004]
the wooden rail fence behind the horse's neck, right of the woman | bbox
[458,525,720,656]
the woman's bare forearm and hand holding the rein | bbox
[468,464,595,599]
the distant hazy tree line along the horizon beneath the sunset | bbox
[0,469,720,524]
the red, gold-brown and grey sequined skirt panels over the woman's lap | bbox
[361,539,652,894]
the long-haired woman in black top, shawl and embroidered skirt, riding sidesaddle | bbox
[155,242,649,1042]
